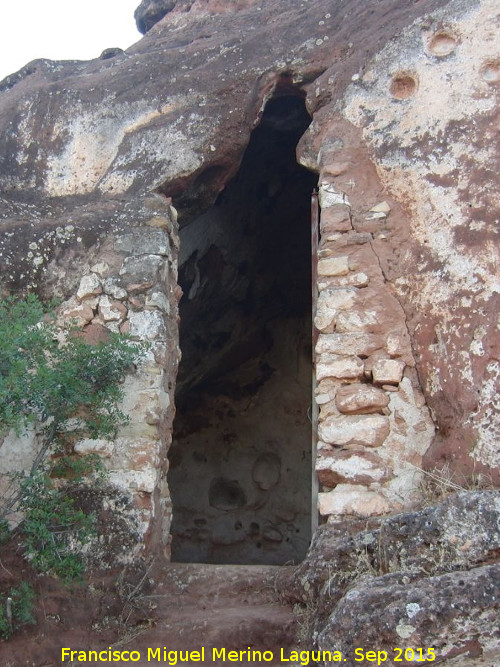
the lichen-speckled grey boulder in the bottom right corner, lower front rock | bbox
[317,563,500,667]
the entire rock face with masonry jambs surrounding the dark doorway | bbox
[0,0,500,560]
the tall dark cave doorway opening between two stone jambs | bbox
[169,95,317,564]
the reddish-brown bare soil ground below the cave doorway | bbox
[0,545,297,667]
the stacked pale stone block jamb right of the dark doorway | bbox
[314,179,434,521]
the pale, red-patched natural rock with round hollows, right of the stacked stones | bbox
[336,1,500,475]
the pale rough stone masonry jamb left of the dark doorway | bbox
[53,207,179,540]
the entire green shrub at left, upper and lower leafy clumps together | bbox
[0,295,146,582]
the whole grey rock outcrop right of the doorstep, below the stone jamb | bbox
[285,491,500,667]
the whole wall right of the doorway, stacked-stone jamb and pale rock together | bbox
[292,2,499,514]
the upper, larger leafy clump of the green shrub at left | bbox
[0,295,144,441]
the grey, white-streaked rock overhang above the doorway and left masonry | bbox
[0,1,450,214]
